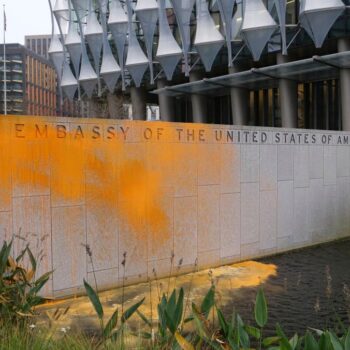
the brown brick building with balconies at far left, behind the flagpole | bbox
[0,44,57,115]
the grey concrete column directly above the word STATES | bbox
[277,54,298,128]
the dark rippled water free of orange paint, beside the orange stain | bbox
[225,240,350,334]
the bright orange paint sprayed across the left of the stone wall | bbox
[0,116,235,253]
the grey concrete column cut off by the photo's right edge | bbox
[338,38,350,131]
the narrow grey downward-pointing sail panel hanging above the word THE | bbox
[171,0,196,76]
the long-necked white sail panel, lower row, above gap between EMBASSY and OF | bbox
[125,0,148,87]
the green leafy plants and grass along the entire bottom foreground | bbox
[0,238,350,350]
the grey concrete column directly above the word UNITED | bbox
[229,67,249,125]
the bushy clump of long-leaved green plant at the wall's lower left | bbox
[0,241,52,324]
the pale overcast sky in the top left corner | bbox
[0,0,55,44]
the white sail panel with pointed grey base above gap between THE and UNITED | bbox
[194,0,224,72]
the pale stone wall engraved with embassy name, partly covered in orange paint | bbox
[0,116,350,296]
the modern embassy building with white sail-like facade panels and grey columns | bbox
[49,0,350,131]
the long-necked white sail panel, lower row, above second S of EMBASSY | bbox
[99,0,120,93]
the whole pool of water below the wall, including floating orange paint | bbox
[42,240,350,335]
